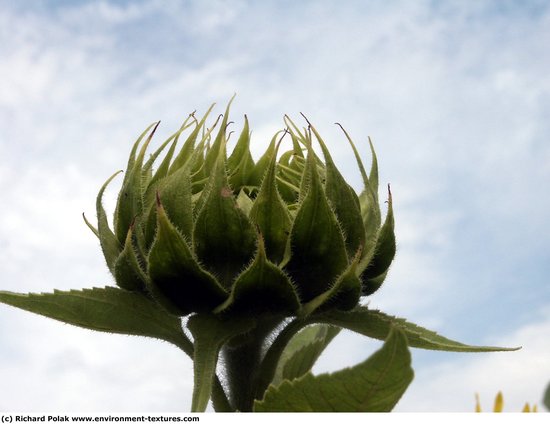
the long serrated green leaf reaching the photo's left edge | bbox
[0,287,192,352]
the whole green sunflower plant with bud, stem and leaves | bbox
[0,100,511,411]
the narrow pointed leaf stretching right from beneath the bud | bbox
[320,306,519,352]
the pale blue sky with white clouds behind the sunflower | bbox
[0,0,550,412]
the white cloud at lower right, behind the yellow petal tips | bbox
[398,306,550,412]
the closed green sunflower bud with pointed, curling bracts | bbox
[87,101,395,316]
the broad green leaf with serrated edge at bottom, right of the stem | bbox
[254,330,414,412]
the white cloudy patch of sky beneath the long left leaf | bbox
[0,308,193,412]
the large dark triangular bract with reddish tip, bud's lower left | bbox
[148,200,227,315]
